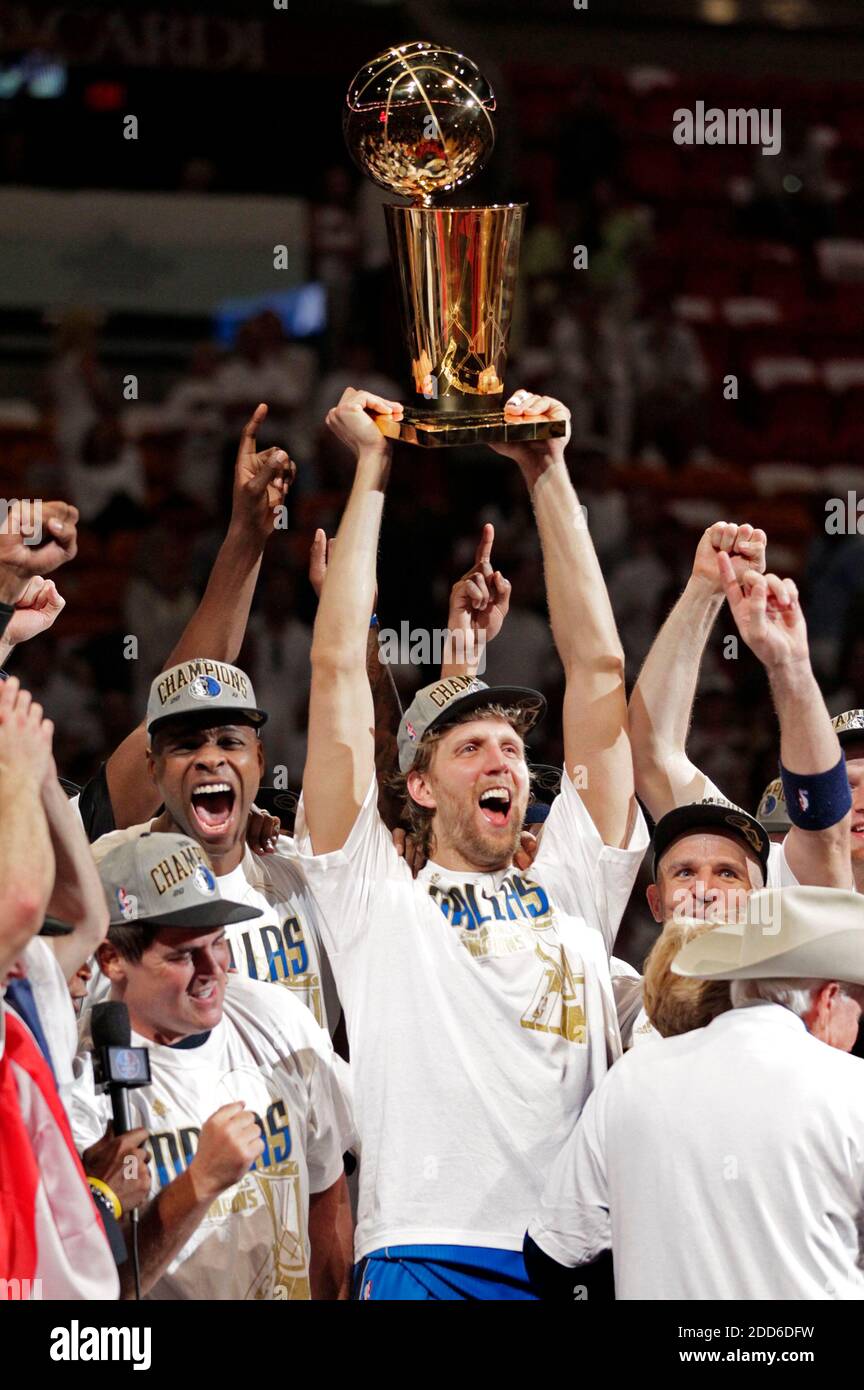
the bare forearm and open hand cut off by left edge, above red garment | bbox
[0,676,54,980]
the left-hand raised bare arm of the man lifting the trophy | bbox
[303,388,401,853]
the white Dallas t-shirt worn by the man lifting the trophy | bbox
[295,776,647,1258]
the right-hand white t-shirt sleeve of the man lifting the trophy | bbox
[533,769,649,952]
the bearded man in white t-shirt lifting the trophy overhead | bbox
[297,389,647,1300]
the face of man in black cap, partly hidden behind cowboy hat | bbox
[647,831,763,922]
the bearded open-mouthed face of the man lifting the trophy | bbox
[407,716,529,873]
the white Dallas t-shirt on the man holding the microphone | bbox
[72,976,353,1300]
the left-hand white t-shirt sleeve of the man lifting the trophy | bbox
[294,776,411,956]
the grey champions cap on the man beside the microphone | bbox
[97,833,261,929]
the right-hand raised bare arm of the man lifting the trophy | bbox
[493,392,636,847]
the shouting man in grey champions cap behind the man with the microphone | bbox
[93,657,339,1030]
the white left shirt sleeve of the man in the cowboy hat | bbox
[528,1063,621,1269]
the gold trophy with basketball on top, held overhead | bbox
[344,43,567,448]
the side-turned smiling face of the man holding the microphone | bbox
[99,927,231,1044]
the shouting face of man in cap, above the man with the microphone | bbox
[147,720,264,873]
